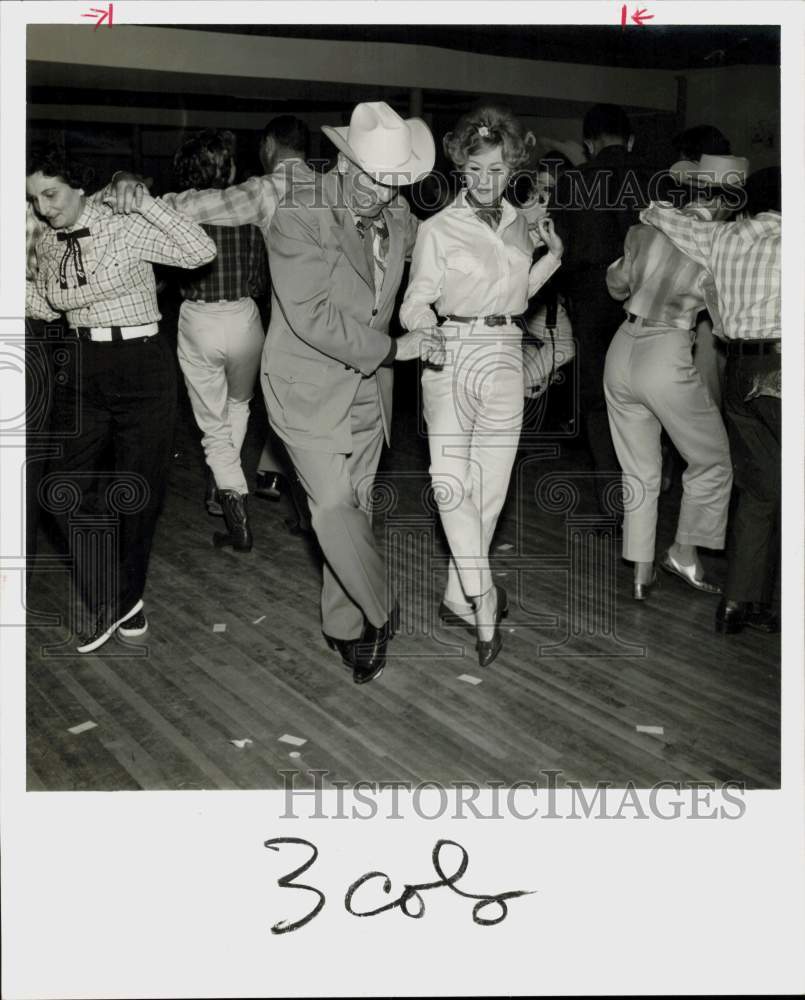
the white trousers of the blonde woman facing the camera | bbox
[422,324,523,608]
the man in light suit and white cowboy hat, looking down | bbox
[262,101,444,684]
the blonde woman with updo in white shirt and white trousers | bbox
[400,105,563,666]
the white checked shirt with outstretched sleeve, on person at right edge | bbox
[640,202,782,340]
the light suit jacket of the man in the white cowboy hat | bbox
[263,170,417,454]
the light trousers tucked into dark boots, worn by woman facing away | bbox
[177,298,265,493]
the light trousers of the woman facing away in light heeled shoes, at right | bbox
[604,320,732,562]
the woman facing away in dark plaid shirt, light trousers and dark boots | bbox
[173,129,268,552]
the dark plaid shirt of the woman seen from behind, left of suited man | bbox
[182,225,268,302]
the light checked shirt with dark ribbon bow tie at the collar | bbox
[25,199,215,327]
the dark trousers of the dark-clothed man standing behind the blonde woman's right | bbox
[570,270,624,504]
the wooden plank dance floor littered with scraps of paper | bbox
[27,365,780,790]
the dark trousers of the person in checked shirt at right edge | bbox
[724,354,781,604]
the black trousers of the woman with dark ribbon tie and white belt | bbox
[44,335,176,614]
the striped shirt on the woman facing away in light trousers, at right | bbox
[607,225,707,330]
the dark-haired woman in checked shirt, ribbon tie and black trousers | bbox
[25,146,216,653]
